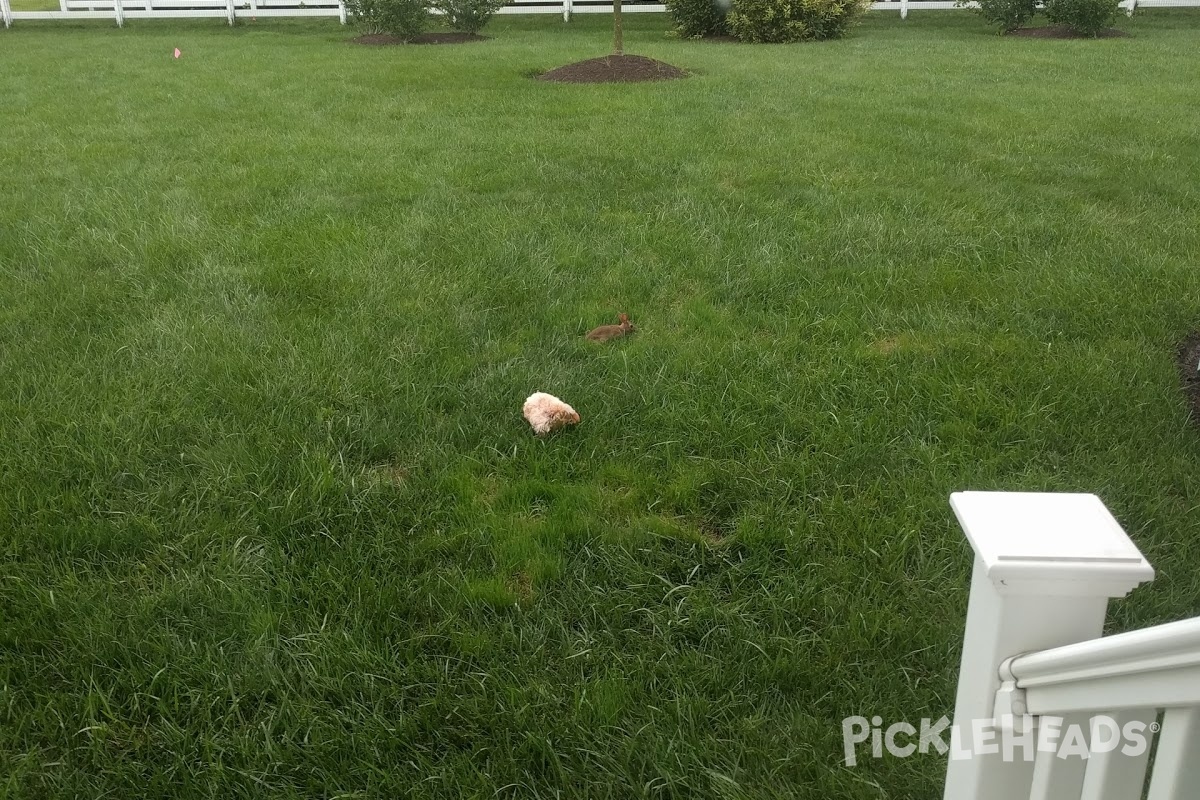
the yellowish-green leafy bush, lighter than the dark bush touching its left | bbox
[726,0,866,42]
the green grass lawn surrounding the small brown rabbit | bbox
[0,10,1200,800]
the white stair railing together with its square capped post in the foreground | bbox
[943,492,1200,800]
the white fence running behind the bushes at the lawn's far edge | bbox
[0,0,1200,28]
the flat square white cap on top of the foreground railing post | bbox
[950,492,1154,597]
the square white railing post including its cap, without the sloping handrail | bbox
[943,492,1154,800]
